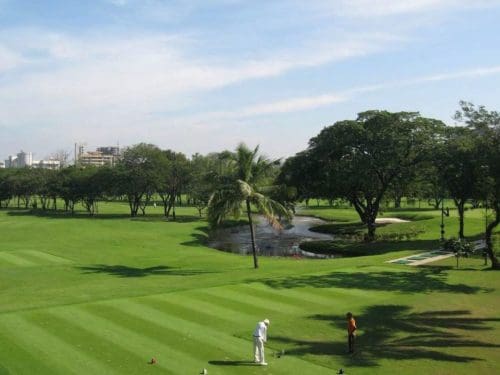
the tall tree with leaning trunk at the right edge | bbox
[455,101,500,269]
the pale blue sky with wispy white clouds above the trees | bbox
[0,0,500,160]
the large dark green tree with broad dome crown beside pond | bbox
[308,111,444,241]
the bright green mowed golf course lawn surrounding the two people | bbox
[0,203,500,374]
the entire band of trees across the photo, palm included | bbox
[0,102,500,267]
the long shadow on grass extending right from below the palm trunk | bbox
[262,267,492,294]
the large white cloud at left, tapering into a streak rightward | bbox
[0,29,399,121]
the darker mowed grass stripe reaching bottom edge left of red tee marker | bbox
[41,309,162,374]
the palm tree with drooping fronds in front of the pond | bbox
[208,143,290,268]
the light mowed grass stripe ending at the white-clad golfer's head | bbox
[146,291,254,323]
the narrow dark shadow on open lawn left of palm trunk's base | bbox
[76,264,212,277]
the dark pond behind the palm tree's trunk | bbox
[208,216,333,258]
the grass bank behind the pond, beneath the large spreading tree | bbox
[298,205,500,256]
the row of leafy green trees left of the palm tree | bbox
[0,143,213,220]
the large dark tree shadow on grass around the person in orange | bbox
[273,305,500,366]
